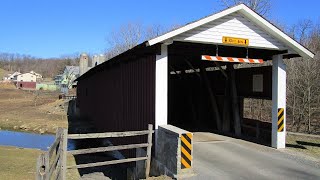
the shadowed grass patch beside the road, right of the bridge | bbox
[286,135,320,160]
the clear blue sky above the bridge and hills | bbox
[0,0,320,58]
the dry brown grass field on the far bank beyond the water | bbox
[0,88,68,133]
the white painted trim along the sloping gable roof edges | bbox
[147,4,314,58]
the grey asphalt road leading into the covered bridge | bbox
[187,133,320,180]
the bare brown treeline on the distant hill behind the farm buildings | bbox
[0,53,79,78]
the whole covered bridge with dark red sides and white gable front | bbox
[77,4,314,148]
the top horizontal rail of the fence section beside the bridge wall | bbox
[68,130,154,139]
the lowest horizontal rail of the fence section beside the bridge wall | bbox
[67,157,147,169]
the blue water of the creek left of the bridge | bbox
[0,130,74,151]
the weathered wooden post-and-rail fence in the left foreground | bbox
[36,124,154,180]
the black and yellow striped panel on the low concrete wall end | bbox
[181,133,192,169]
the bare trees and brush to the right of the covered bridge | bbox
[286,20,320,133]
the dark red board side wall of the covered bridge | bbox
[77,56,155,132]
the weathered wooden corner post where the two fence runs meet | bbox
[60,129,68,180]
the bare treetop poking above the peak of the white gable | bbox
[221,0,271,16]
